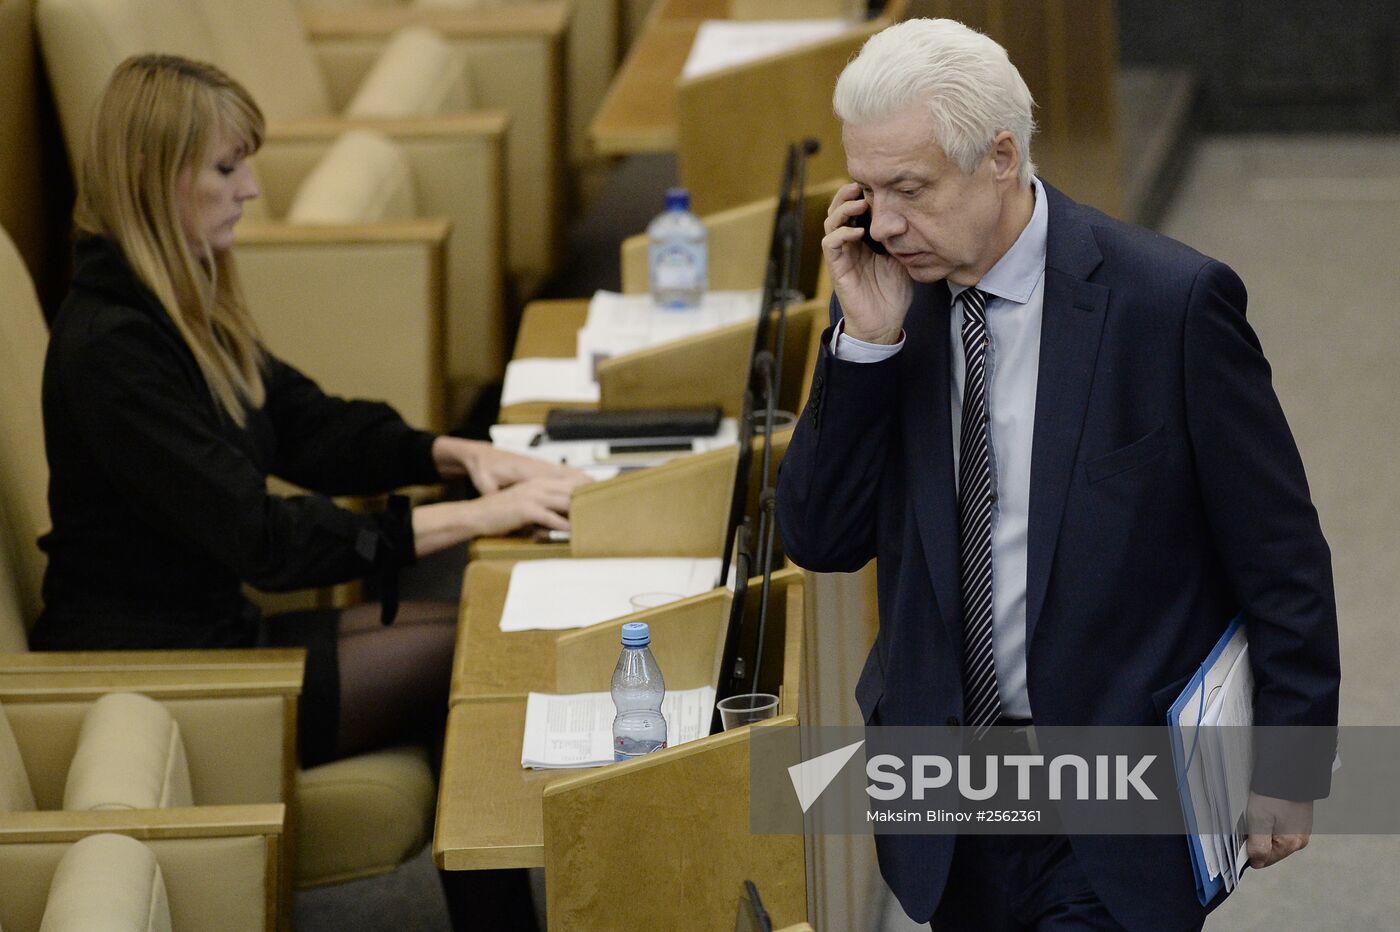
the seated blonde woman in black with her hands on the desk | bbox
[31,55,584,783]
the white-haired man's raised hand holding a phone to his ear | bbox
[822,182,914,344]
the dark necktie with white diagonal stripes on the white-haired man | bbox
[958,288,1001,737]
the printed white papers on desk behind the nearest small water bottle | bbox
[521,686,714,770]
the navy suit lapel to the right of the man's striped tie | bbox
[1026,185,1109,648]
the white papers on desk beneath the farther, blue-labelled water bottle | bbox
[578,291,763,378]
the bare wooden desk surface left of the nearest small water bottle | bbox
[433,696,580,870]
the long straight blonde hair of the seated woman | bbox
[73,55,265,427]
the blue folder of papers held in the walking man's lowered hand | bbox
[1168,619,1254,904]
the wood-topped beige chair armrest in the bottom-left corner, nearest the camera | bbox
[0,805,291,932]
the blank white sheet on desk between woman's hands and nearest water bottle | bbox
[501,557,720,632]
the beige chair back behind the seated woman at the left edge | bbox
[0,230,49,651]
